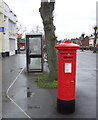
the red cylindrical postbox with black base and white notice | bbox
[55,40,80,114]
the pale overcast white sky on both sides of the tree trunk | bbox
[4,0,97,40]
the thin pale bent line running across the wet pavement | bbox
[6,68,32,120]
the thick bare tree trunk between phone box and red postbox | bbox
[39,0,57,81]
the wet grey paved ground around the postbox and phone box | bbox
[0,50,98,120]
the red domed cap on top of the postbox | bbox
[55,40,80,50]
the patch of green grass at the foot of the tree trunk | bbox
[36,74,57,88]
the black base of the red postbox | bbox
[57,99,75,114]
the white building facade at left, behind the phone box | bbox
[0,1,17,57]
